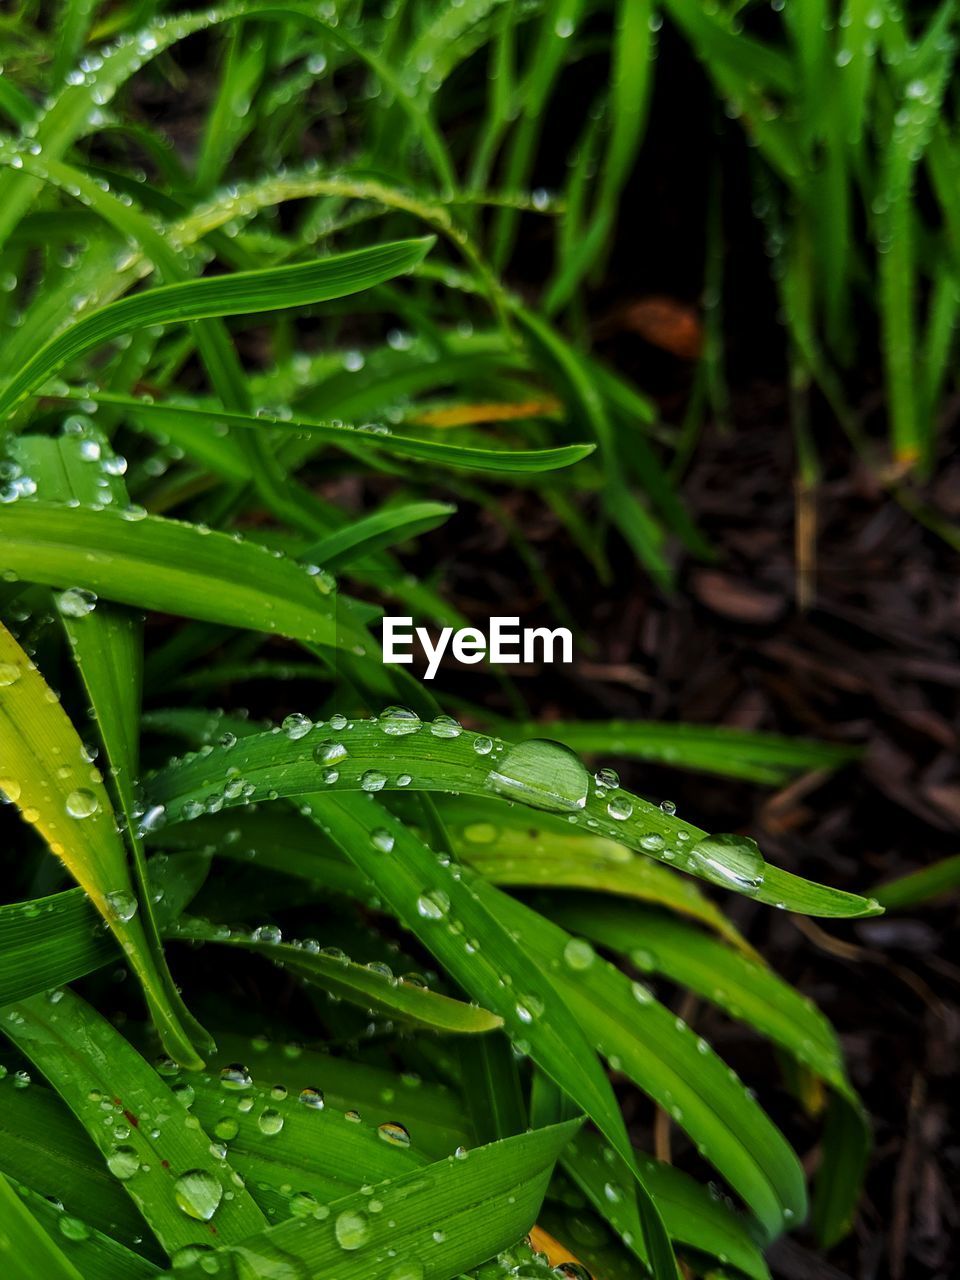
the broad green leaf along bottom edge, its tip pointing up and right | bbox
[168,1121,579,1280]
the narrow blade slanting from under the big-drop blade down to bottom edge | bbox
[307,794,676,1280]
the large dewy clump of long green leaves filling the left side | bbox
[0,10,896,1280]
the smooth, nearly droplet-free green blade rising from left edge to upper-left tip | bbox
[0,237,433,415]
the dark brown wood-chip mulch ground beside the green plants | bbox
[422,387,960,1280]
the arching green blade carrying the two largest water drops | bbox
[148,721,881,916]
